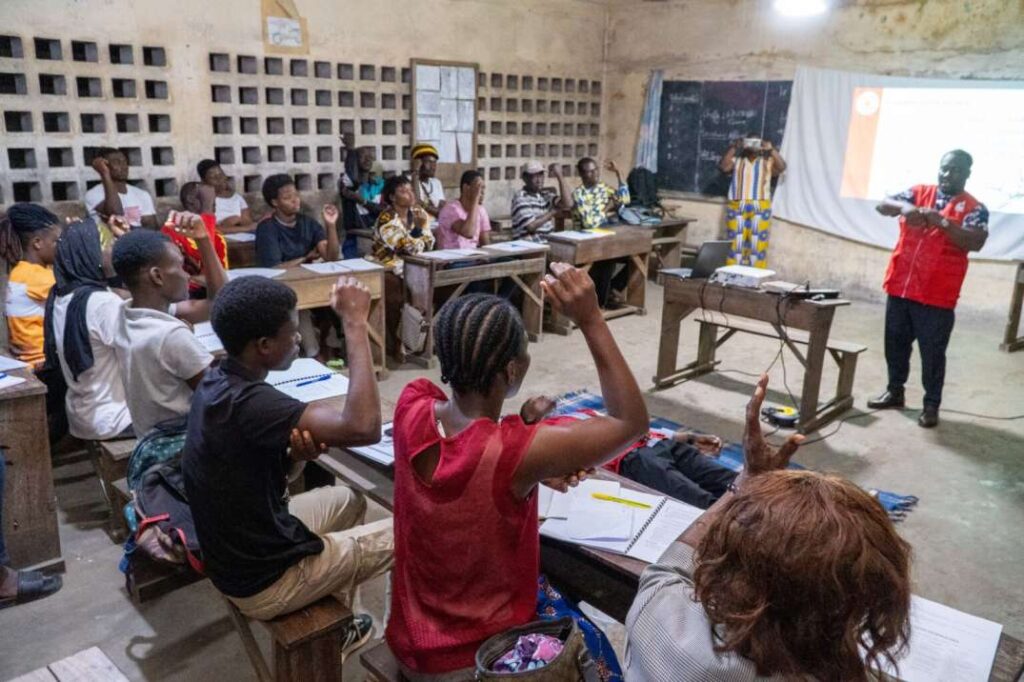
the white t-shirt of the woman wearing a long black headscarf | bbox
[53,291,131,440]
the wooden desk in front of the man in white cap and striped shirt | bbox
[548,225,653,334]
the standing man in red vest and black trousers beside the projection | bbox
[867,150,988,428]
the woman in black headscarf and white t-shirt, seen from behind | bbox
[46,220,133,440]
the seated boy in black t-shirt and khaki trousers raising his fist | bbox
[181,276,394,646]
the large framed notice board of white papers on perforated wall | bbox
[413,59,477,169]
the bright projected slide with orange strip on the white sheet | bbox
[840,87,1024,214]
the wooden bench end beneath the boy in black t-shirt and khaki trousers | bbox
[224,596,352,682]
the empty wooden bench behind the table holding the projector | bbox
[693,312,867,432]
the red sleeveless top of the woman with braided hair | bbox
[386,379,541,674]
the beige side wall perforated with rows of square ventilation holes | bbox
[0,0,605,216]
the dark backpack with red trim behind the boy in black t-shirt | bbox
[121,417,203,574]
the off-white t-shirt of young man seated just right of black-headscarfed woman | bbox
[115,300,213,437]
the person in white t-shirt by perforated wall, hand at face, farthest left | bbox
[85,146,159,229]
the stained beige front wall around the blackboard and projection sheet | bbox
[602,0,1024,314]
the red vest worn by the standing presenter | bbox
[883,184,979,309]
